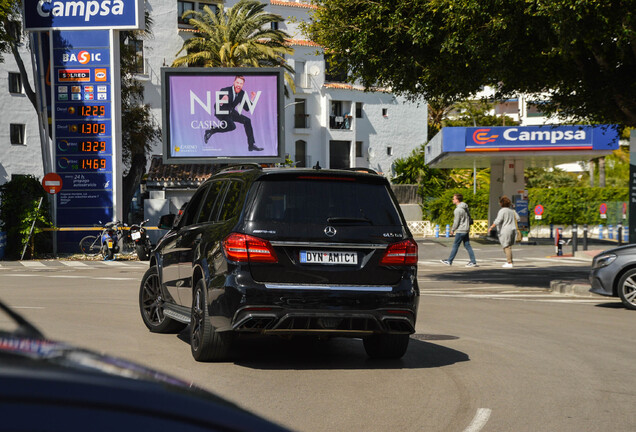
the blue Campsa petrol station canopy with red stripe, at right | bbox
[425,125,618,168]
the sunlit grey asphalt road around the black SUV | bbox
[0,241,636,432]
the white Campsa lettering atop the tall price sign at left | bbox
[37,0,124,22]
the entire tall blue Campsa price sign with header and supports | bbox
[21,0,144,251]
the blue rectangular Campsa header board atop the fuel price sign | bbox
[23,0,144,31]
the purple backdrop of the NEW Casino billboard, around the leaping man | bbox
[168,74,279,158]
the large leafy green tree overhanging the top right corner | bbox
[305,0,636,126]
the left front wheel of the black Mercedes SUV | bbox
[139,266,186,333]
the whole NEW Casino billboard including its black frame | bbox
[161,68,285,164]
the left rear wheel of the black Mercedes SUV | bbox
[190,279,233,361]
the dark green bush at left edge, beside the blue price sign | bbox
[0,176,51,259]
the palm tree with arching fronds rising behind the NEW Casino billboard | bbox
[172,0,295,91]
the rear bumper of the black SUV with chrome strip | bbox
[226,280,419,337]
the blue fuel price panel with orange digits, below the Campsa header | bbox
[52,30,114,226]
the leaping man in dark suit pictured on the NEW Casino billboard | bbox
[203,75,263,151]
